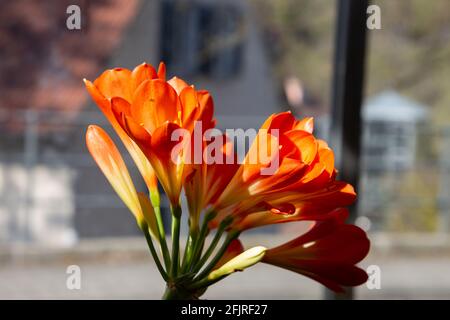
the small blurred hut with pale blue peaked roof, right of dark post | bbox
[360,91,429,229]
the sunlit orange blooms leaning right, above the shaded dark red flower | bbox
[205,112,356,230]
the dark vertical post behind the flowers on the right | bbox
[326,0,368,299]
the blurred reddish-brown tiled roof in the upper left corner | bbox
[0,0,140,131]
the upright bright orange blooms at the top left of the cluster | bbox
[86,63,218,206]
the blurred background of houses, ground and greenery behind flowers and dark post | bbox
[0,0,450,299]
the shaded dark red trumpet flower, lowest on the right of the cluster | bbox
[262,209,370,292]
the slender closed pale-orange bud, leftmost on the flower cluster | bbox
[86,125,157,239]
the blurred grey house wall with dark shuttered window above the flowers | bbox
[109,0,281,128]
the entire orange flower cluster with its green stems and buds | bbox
[85,63,370,299]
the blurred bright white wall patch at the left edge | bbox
[0,164,77,247]
